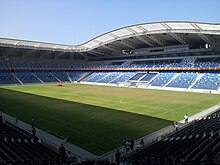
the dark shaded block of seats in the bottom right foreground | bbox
[123,111,220,165]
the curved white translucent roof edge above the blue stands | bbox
[0,21,220,52]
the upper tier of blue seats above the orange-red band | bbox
[0,58,220,69]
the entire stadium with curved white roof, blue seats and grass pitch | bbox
[0,21,220,164]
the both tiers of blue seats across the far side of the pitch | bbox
[0,58,219,90]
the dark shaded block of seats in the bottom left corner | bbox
[0,121,62,165]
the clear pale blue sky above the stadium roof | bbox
[0,0,220,45]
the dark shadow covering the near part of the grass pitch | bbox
[0,88,171,155]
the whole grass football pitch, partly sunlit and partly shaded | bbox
[0,84,220,155]
